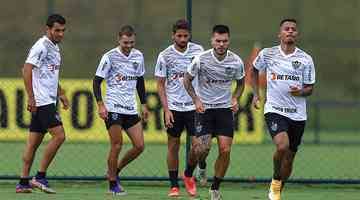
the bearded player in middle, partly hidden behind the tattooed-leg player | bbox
[155,19,206,197]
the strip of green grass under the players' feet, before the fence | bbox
[0,182,360,200]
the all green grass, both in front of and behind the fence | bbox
[0,133,360,200]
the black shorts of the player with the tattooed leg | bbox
[195,108,234,137]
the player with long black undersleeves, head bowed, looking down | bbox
[93,25,148,195]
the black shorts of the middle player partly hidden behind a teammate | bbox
[166,110,195,137]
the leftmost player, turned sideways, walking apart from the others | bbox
[16,14,69,193]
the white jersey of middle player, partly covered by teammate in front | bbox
[155,42,204,111]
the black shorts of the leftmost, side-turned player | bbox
[29,104,62,134]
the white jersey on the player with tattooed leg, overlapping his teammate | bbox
[187,49,245,109]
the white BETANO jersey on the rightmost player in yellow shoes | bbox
[253,46,315,121]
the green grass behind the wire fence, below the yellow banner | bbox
[0,142,360,180]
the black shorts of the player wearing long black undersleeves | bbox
[105,112,141,130]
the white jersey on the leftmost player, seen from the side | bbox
[25,36,61,107]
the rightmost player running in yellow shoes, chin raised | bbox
[253,19,315,200]
